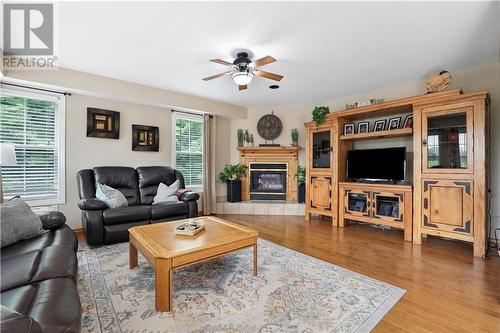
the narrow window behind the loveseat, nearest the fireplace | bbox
[172,112,203,187]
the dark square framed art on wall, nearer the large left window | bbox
[87,107,120,139]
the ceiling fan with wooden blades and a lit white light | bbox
[203,52,283,90]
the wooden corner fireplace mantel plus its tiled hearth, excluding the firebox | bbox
[217,147,304,215]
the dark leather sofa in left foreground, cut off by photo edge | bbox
[0,212,81,333]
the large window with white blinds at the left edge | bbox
[0,87,65,206]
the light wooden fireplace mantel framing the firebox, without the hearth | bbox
[238,146,301,202]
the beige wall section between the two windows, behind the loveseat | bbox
[59,94,172,229]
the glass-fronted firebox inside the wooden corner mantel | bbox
[249,163,288,200]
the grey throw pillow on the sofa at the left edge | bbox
[0,198,42,247]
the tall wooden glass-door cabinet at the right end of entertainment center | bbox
[413,93,489,257]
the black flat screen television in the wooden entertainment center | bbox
[347,147,406,182]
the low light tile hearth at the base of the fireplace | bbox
[217,201,304,216]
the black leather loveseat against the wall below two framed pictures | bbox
[77,166,199,245]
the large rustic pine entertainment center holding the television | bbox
[305,88,490,257]
